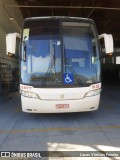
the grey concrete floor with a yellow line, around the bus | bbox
[0,85,120,160]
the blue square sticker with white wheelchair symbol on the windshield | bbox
[64,73,74,84]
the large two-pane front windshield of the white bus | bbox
[21,19,100,87]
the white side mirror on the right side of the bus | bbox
[99,33,113,54]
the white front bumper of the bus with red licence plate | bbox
[21,95,100,113]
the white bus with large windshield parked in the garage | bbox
[6,17,113,113]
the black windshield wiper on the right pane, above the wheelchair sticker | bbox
[64,58,83,86]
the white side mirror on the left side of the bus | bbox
[6,33,20,56]
